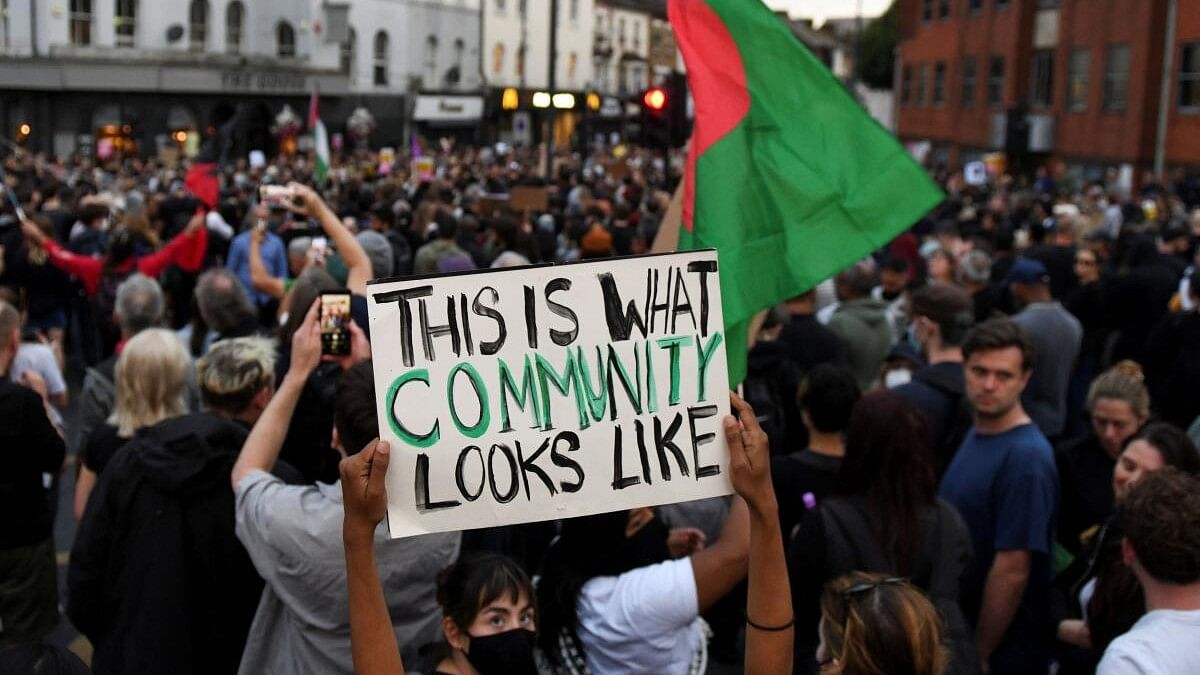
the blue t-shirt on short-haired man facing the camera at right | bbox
[941,423,1058,671]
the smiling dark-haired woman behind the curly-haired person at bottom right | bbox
[1051,423,1200,675]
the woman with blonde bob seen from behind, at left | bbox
[74,328,192,518]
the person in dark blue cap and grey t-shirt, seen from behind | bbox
[1004,257,1084,442]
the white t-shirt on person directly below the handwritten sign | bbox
[577,557,703,675]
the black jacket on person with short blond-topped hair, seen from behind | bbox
[67,413,263,675]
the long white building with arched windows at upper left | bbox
[0,0,482,155]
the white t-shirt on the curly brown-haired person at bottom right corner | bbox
[1096,609,1200,675]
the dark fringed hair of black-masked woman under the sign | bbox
[438,551,538,631]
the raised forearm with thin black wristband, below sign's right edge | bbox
[745,502,794,675]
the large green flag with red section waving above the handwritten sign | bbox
[667,0,942,384]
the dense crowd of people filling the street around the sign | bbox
[0,138,1200,675]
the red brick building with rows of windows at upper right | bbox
[896,0,1200,178]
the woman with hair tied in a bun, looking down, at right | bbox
[1055,360,1150,555]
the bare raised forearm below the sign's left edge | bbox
[343,531,404,675]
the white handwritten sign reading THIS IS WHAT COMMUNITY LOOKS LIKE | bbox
[367,250,732,537]
